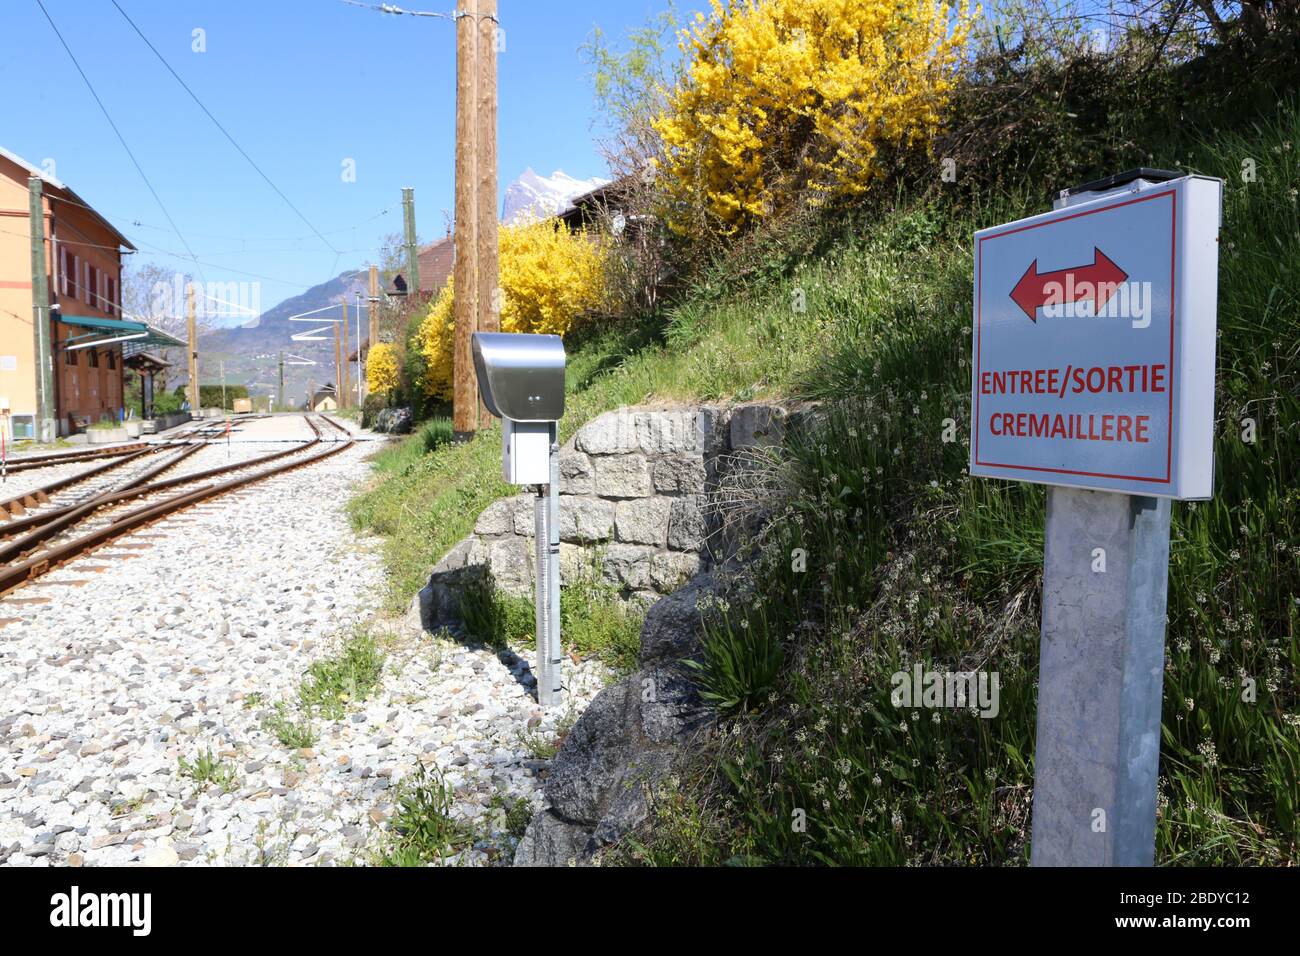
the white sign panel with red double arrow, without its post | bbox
[971,177,1222,499]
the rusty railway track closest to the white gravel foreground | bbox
[0,415,355,596]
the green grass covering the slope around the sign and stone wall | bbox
[352,103,1300,865]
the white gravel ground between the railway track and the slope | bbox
[0,419,608,866]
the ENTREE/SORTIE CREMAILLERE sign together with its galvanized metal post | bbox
[971,169,1222,866]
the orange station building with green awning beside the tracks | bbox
[0,148,182,438]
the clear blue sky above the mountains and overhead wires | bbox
[0,0,703,308]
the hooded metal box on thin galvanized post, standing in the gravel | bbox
[473,332,566,708]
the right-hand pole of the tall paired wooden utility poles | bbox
[471,0,502,427]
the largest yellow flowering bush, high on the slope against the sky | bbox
[654,0,975,234]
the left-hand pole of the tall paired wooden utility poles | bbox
[451,0,483,441]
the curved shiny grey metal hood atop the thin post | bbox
[473,332,566,421]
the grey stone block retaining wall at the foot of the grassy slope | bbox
[412,405,792,631]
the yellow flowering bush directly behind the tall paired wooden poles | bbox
[416,220,607,399]
